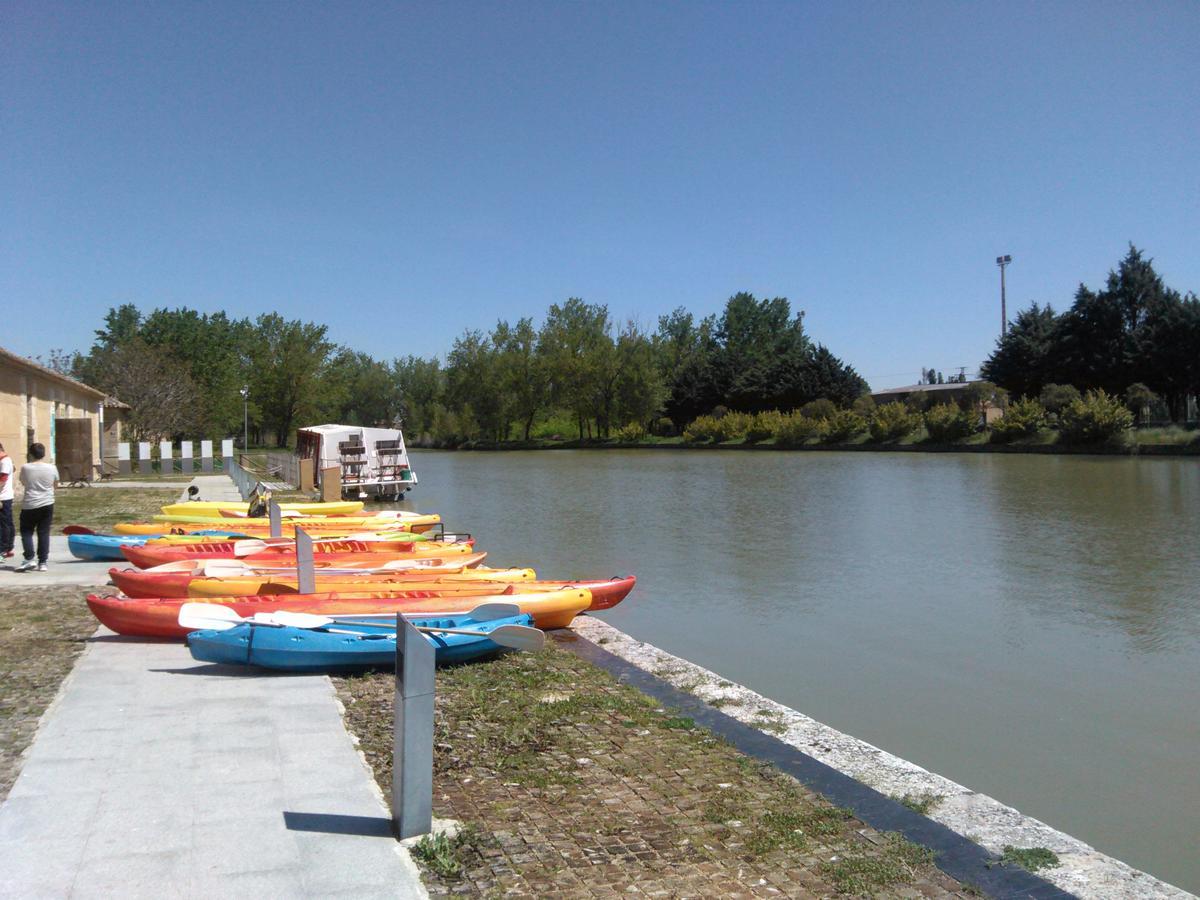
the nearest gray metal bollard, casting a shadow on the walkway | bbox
[391,613,434,840]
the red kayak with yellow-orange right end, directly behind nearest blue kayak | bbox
[88,588,592,637]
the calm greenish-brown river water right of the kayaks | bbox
[409,450,1200,890]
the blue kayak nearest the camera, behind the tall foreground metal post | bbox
[187,614,533,672]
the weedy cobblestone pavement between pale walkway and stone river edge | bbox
[338,649,967,898]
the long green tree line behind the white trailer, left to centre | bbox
[60,293,868,446]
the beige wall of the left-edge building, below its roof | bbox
[0,361,100,480]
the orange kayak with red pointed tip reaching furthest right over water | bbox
[181,572,637,611]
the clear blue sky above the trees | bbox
[0,0,1200,388]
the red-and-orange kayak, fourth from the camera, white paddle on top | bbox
[108,559,535,598]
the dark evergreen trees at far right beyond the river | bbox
[980,245,1200,422]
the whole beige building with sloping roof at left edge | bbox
[0,347,128,481]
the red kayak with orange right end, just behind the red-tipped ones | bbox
[121,540,482,569]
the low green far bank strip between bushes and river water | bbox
[409,430,1200,456]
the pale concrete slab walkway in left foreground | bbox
[0,479,426,898]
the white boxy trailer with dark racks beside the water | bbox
[296,425,416,500]
